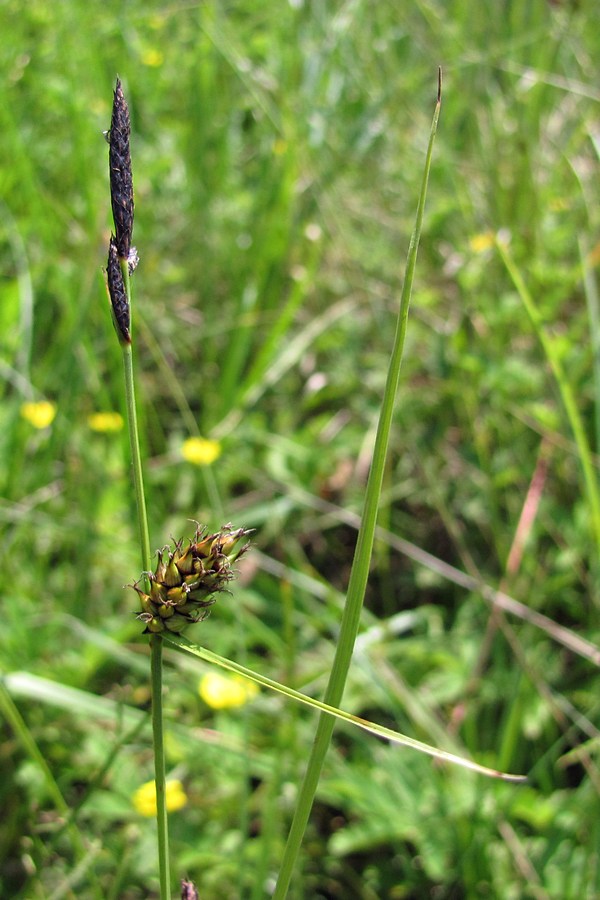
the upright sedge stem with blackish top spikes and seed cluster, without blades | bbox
[106,79,249,900]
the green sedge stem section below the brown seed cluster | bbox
[150,634,171,900]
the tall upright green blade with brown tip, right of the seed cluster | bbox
[273,70,441,900]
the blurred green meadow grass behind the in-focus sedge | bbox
[0,0,600,900]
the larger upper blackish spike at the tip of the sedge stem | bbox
[108,78,133,262]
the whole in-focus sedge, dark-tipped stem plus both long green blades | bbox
[106,71,522,900]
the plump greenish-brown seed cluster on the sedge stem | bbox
[133,525,250,634]
